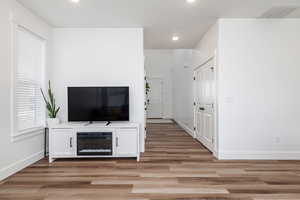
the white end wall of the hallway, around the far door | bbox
[145,49,174,119]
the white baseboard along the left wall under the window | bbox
[0,151,44,181]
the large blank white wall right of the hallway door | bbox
[219,19,300,159]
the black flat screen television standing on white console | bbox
[68,87,129,122]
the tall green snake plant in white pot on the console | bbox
[41,81,60,127]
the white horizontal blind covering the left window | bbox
[15,27,45,135]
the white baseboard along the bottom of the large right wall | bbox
[218,150,300,160]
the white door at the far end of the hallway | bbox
[147,78,163,119]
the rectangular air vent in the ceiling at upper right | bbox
[260,6,299,18]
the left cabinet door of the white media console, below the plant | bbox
[50,130,76,156]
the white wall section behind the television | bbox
[51,28,145,150]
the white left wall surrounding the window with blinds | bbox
[0,0,51,180]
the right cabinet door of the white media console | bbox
[115,128,138,157]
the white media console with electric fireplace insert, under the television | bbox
[49,123,140,163]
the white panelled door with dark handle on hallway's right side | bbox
[195,59,215,151]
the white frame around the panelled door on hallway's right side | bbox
[193,50,219,158]
